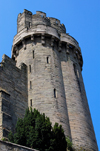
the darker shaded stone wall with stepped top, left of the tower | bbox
[0,55,28,138]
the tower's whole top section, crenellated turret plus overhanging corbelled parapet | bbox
[12,9,83,68]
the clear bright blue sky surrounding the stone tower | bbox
[0,0,100,149]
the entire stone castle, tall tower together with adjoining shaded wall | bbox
[0,10,98,151]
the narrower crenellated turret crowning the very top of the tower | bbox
[17,9,66,33]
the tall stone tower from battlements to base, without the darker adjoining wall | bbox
[12,10,98,151]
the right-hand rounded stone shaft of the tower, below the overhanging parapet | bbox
[60,47,98,150]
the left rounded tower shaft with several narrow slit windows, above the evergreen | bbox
[16,36,71,138]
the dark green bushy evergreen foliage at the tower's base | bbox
[8,109,67,151]
